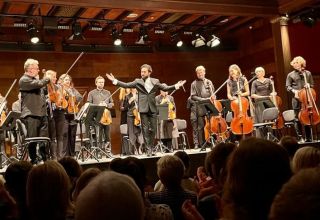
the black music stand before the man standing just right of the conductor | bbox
[197,99,219,151]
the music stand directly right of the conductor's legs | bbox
[154,104,169,153]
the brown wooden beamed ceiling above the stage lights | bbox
[0,0,318,50]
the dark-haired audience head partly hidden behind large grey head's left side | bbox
[72,168,101,201]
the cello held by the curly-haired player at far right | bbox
[298,71,320,125]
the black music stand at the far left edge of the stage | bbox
[0,111,21,169]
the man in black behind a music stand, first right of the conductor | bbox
[190,66,215,148]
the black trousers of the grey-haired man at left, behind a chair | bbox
[22,116,48,163]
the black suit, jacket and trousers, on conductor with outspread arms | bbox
[116,78,175,153]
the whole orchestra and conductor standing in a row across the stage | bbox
[0,56,320,164]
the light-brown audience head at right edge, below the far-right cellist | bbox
[292,146,320,173]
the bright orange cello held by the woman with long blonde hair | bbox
[230,78,253,135]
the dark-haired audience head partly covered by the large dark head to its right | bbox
[205,143,236,186]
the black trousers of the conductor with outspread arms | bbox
[140,111,157,151]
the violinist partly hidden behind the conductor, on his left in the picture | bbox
[123,88,143,155]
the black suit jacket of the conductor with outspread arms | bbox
[116,78,175,113]
